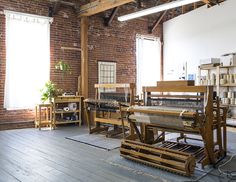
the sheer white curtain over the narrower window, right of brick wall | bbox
[136,35,161,95]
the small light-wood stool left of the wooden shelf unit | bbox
[34,104,54,130]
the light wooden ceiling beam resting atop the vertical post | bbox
[79,0,135,17]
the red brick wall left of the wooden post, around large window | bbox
[0,0,80,123]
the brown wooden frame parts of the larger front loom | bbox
[121,86,227,176]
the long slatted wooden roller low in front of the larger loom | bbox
[120,140,196,176]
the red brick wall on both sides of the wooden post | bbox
[0,0,160,128]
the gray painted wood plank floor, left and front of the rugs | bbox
[0,126,236,182]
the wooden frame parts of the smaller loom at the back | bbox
[85,83,135,137]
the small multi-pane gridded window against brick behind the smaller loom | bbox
[98,61,116,92]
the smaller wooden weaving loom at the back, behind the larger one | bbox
[84,83,135,137]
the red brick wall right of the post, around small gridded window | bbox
[89,13,160,97]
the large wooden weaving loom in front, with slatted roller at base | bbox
[120,86,227,176]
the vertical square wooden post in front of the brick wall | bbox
[81,17,88,99]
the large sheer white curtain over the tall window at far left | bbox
[4,11,52,109]
